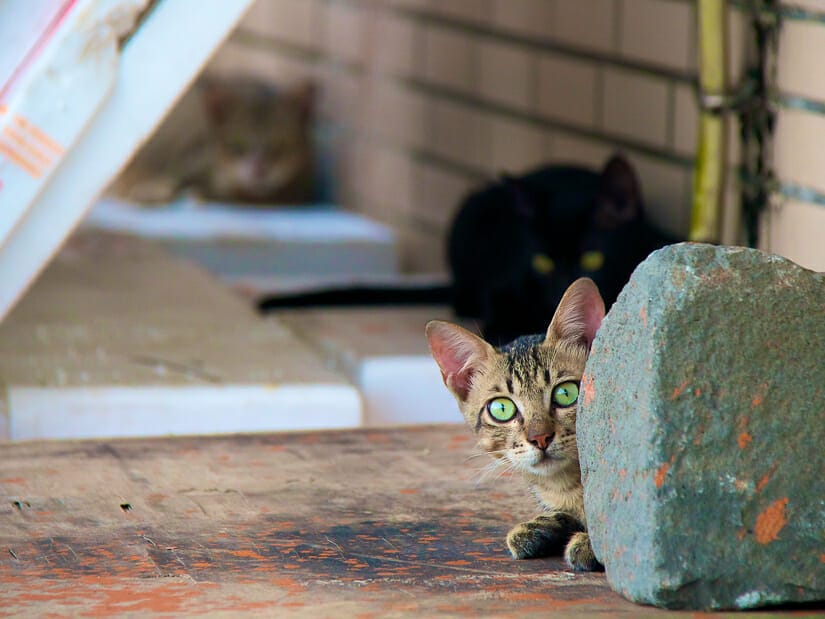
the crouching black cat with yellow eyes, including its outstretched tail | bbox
[258,155,673,345]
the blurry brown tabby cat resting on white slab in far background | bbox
[110,78,315,204]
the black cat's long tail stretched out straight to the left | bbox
[258,285,453,313]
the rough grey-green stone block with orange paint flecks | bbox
[577,243,825,609]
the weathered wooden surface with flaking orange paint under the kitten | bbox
[0,426,816,618]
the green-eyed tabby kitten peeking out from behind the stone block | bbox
[426,278,605,571]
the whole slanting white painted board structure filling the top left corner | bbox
[0,0,251,319]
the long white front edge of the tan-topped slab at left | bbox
[7,384,361,440]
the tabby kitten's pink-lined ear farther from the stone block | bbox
[426,320,495,402]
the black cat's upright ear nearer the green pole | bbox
[595,153,643,228]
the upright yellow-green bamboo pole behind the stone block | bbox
[689,0,727,242]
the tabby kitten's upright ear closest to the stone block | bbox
[546,277,604,349]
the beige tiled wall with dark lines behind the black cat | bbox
[201,0,825,270]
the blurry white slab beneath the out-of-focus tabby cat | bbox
[84,197,398,292]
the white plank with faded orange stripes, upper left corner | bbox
[0,0,146,245]
